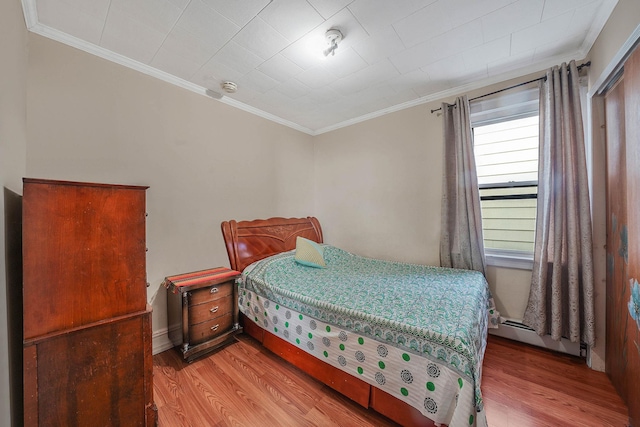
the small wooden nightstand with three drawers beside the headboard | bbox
[163,267,242,362]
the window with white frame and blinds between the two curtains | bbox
[471,85,538,268]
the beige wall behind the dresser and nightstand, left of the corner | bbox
[27,34,314,352]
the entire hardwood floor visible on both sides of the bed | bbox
[153,335,628,427]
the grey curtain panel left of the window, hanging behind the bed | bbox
[440,96,485,274]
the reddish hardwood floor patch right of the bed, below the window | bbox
[482,336,629,427]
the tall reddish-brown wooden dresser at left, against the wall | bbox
[23,178,157,426]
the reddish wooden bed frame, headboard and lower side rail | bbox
[221,217,435,427]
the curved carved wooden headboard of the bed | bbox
[221,216,322,271]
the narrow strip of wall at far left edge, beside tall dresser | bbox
[0,0,27,426]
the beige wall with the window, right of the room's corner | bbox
[314,73,541,320]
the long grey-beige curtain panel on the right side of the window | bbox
[523,61,595,345]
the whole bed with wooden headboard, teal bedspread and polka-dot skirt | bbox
[221,217,497,427]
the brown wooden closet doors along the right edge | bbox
[605,43,640,425]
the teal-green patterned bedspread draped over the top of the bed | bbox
[242,245,497,426]
